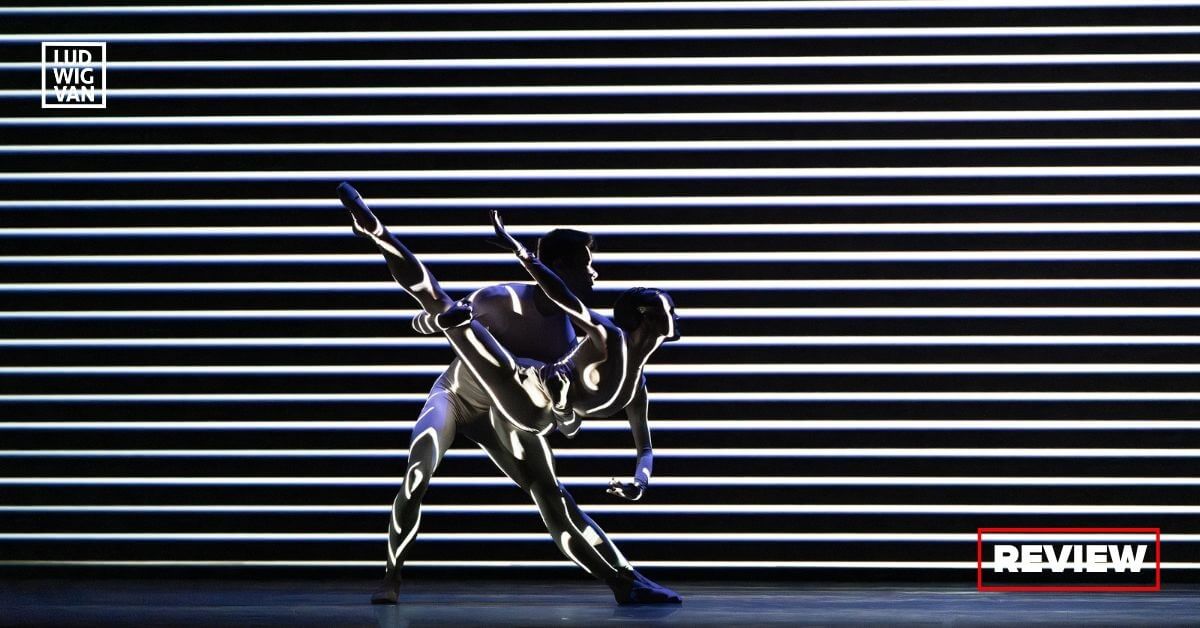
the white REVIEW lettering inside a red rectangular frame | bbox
[976,527,1163,591]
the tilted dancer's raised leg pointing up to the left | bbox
[337,184,554,433]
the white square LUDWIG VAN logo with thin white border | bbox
[42,42,108,109]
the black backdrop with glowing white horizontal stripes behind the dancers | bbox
[0,0,1200,584]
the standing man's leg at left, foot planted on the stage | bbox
[371,387,457,604]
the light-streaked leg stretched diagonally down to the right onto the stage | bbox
[464,413,680,604]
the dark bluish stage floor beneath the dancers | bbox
[0,580,1200,627]
